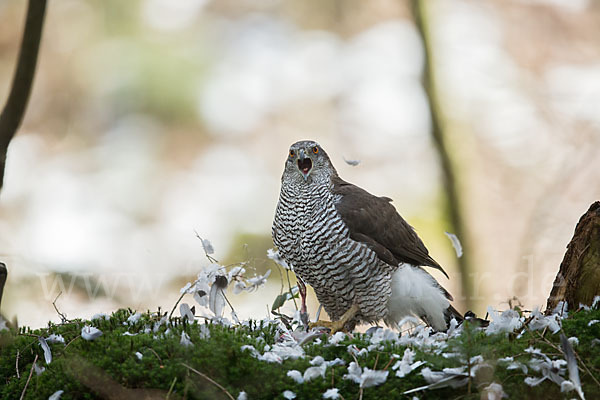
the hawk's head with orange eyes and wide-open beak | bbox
[283,140,337,182]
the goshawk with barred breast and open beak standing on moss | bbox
[272,140,462,331]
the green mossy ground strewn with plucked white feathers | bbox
[0,310,600,400]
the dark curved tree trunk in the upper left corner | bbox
[0,0,46,190]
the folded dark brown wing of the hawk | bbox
[332,177,448,277]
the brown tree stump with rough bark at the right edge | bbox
[546,201,600,312]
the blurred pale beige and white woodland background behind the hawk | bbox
[0,0,600,326]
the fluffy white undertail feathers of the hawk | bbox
[386,264,450,331]
